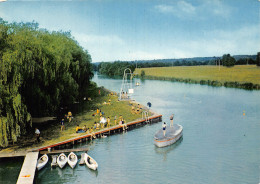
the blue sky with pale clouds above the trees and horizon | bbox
[0,0,260,62]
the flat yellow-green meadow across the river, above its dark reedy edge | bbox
[135,65,260,85]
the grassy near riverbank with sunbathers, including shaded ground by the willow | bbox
[0,94,152,155]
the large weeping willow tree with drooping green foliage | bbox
[0,19,93,147]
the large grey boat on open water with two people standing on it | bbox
[154,124,183,147]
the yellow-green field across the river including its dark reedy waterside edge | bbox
[135,65,260,89]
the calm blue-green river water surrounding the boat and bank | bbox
[0,75,260,184]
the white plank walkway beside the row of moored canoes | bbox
[16,152,39,184]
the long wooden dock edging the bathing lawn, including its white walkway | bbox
[4,114,162,184]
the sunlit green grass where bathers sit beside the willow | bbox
[2,95,151,152]
